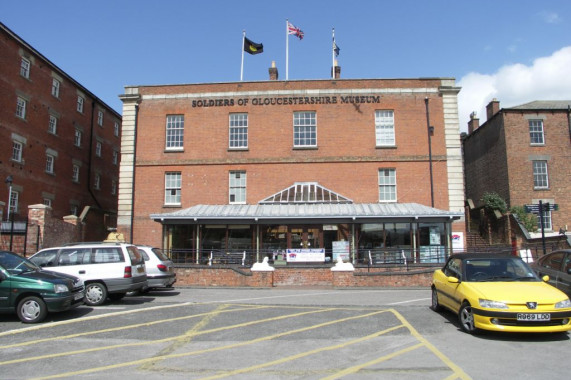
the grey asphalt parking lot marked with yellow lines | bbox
[0,288,571,379]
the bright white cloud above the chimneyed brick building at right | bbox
[458,46,571,132]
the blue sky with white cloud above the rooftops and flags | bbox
[0,0,571,130]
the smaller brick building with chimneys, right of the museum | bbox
[463,99,571,238]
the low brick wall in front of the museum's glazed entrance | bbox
[175,266,435,288]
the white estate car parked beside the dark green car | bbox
[30,242,147,306]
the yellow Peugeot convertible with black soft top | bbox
[432,253,571,334]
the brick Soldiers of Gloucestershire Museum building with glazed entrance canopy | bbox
[118,67,465,270]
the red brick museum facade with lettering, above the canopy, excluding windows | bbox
[118,78,465,252]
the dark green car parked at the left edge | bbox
[0,251,85,323]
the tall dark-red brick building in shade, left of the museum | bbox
[0,23,121,247]
